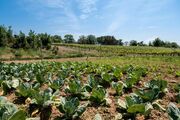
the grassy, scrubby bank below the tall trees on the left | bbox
[0,47,93,61]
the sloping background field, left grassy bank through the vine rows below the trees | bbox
[0,44,180,61]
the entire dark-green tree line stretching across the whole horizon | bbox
[0,25,179,49]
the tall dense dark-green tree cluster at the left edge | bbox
[0,25,61,49]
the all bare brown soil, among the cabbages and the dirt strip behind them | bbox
[0,57,180,120]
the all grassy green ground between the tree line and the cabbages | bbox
[0,44,180,63]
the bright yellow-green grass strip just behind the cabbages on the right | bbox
[90,56,180,66]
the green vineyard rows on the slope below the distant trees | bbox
[54,44,180,57]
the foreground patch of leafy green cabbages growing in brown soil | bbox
[0,62,180,120]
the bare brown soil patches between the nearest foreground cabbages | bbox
[2,76,177,120]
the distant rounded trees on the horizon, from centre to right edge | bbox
[77,35,180,48]
